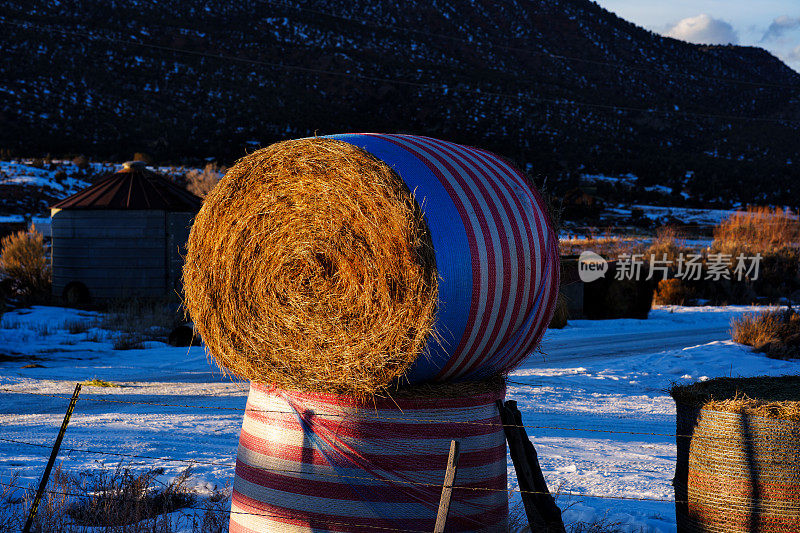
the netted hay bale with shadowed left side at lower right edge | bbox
[672,376,800,533]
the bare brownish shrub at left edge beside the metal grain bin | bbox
[0,225,51,301]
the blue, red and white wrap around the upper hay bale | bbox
[331,134,559,383]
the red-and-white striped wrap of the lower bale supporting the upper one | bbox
[230,383,508,533]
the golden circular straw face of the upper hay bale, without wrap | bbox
[184,139,438,399]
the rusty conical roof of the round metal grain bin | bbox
[50,162,203,212]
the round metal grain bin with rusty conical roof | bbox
[50,161,202,303]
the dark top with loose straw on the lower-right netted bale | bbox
[670,376,800,421]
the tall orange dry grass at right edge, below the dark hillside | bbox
[712,206,800,256]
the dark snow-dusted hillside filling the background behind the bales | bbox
[0,0,800,204]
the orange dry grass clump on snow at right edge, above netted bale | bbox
[731,308,800,358]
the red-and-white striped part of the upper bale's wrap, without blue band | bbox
[374,135,559,381]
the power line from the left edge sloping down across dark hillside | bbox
[0,20,800,126]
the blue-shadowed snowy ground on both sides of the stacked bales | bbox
[0,306,800,532]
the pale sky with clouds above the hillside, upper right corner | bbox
[596,0,800,72]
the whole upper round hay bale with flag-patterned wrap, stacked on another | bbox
[184,134,559,399]
